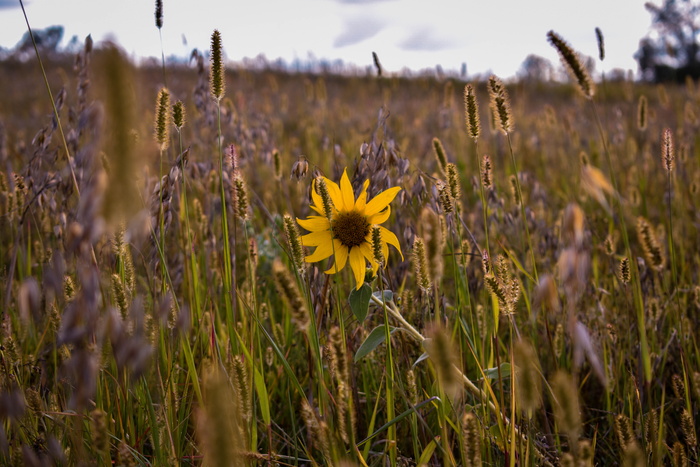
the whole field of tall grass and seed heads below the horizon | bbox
[0,26,700,466]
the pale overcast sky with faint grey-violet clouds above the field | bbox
[0,0,661,79]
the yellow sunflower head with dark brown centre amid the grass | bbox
[297,169,403,289]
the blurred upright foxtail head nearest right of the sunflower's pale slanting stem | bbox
[513,339,542,417]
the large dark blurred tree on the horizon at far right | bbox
[635,0,700,82]
